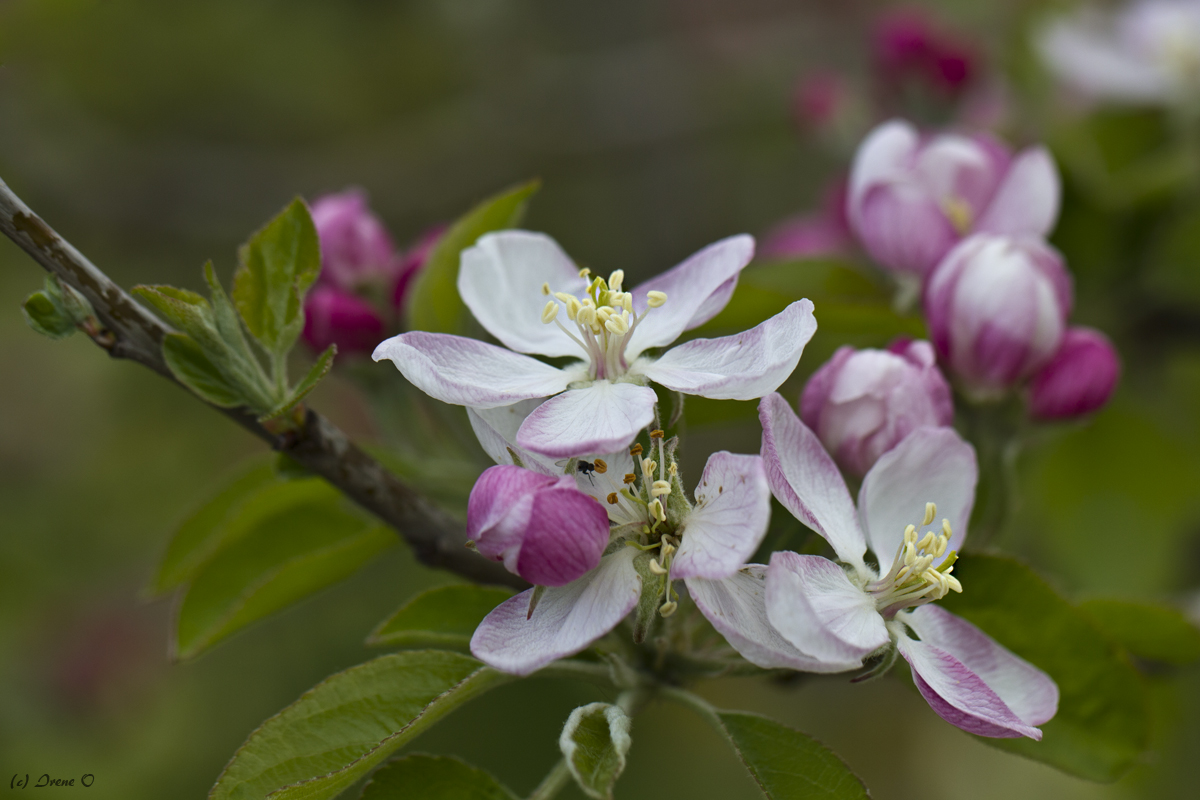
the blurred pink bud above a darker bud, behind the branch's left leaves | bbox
[312,190,397,291]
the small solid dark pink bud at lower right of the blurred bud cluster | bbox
[1030,327,1121,420]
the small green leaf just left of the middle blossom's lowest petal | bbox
[367,584,512,648]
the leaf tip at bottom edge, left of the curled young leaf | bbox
[359,753,517,800]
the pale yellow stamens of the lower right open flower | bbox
[866,503,962,619]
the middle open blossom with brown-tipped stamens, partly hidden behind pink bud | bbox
[470,402,772,675]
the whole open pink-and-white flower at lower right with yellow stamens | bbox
[715,395,1058,739]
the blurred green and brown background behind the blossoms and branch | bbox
[0,0,1200,800]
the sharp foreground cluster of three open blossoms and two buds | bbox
[374,217,1057,739]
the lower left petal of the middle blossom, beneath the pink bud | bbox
[470,547,642,675]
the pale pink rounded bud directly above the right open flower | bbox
[800,339,954,477]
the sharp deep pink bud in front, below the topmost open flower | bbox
[467,464,608,587]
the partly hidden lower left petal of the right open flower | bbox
[685,564,862,673]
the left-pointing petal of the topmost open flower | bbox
[371,331,580,408]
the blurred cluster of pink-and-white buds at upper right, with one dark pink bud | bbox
[847,121,1118,419]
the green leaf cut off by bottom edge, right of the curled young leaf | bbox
[716,711,870,800]
